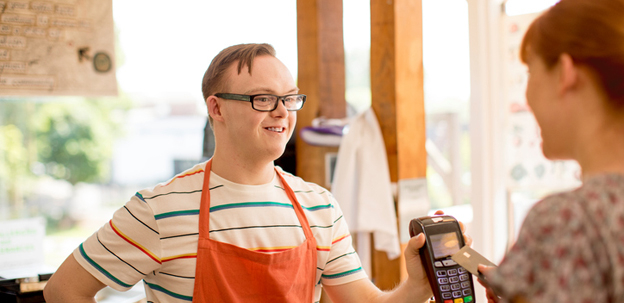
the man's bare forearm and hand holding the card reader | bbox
[323,234,433,303]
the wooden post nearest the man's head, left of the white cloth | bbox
[296,0,347,188]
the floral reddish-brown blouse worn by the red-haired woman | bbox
[489,174,624,303]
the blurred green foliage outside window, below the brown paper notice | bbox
[0,97,130,219]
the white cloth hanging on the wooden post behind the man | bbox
[331,108,401,273]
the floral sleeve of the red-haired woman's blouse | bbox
[489,193,603,303]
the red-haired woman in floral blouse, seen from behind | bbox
[480,0,624,303]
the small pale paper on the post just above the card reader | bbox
[397,178,431,243]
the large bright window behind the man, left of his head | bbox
[0,0,297,278]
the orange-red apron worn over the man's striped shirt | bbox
[193,160,316,303]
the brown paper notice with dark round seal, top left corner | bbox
[0,0,117,96]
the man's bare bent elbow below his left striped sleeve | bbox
[43,255,106,303]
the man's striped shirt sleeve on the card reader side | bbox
[321,196,368,285]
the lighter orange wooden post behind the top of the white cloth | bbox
[371,0,427,289]
